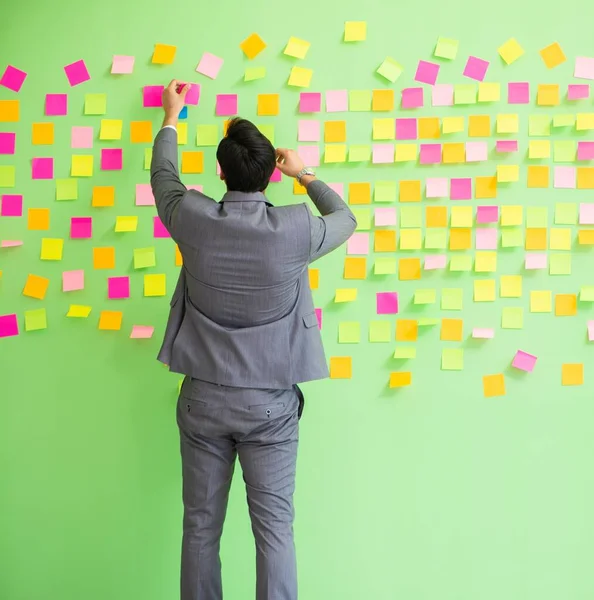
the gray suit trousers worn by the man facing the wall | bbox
[177,377,299,600]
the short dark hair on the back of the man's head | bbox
[217,117,276,192]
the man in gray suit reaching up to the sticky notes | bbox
[151,80,356,600]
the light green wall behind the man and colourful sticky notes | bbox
[0,0,594,600]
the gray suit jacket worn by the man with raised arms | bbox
[151,128,356,389]
